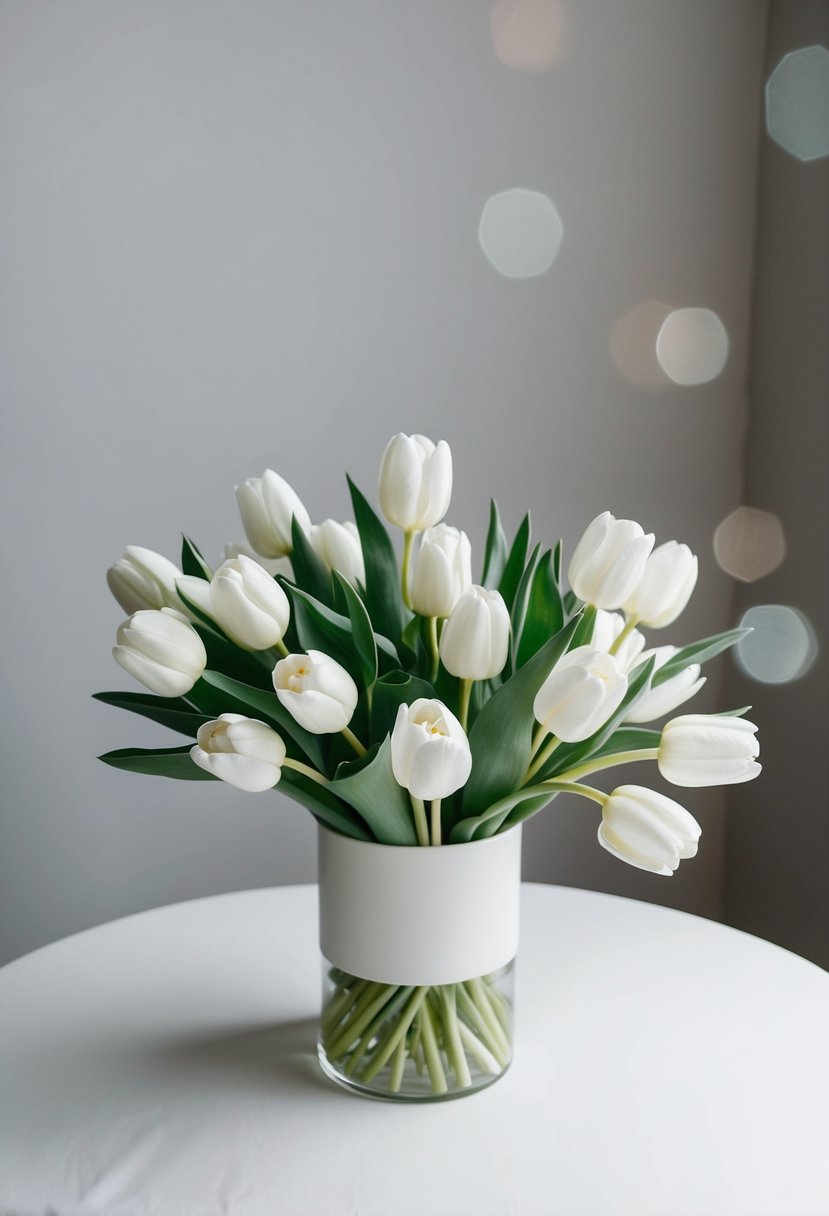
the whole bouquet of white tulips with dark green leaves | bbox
[97,434,760,1099]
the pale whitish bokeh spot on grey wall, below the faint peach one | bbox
[478,188,564,278]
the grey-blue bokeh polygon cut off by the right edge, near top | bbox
[766,46,829,161]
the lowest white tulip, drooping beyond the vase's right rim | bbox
[599,786,703,876]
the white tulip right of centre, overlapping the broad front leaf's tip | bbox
[532,646,627,743]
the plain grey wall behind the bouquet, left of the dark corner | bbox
[0,0,825,961]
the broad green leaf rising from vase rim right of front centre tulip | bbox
[463,620,577,815]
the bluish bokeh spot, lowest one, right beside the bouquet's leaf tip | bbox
[735,604,818,683]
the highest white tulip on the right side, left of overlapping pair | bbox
[568,511,654,609]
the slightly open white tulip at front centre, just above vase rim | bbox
[391,697,472,799]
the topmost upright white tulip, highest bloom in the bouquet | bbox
[379,434,452,531]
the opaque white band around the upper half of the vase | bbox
[318,824,521,985]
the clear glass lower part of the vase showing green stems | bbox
[318,959,514,1102]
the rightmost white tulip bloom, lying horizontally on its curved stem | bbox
[656,714,761,786]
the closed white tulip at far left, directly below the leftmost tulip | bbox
[112,608,207,697]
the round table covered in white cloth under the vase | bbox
[0,885,829,1216]
